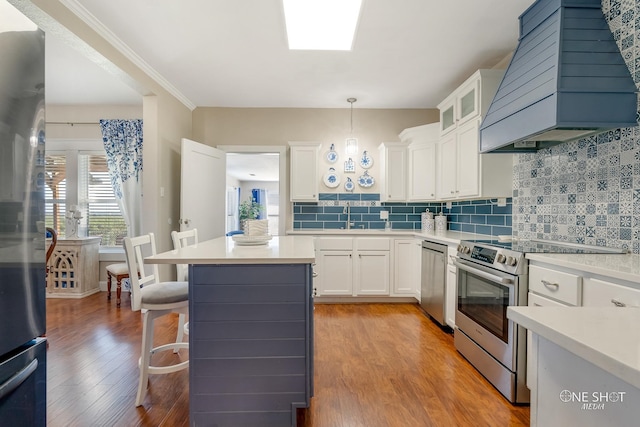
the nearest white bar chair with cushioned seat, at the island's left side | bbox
[124,233,189,406]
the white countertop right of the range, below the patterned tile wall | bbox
[526,254,640,283]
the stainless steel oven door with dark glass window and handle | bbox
[454,259,518,371]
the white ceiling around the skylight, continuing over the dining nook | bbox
[38,0,533,108]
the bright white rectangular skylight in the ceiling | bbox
[282,0,362,50]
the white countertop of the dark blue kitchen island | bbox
[145,236,315,264]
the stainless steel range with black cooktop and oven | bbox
[454,240,625,403]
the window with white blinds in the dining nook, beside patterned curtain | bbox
[45,150,127,246]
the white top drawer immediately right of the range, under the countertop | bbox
[529,265,582,305]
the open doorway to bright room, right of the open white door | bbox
[218,145,287,235]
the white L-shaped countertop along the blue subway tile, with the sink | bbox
[287,228,495,245]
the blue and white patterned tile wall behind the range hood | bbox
[513,0,640,253]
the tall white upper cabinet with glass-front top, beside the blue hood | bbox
[436,70,513,200]
